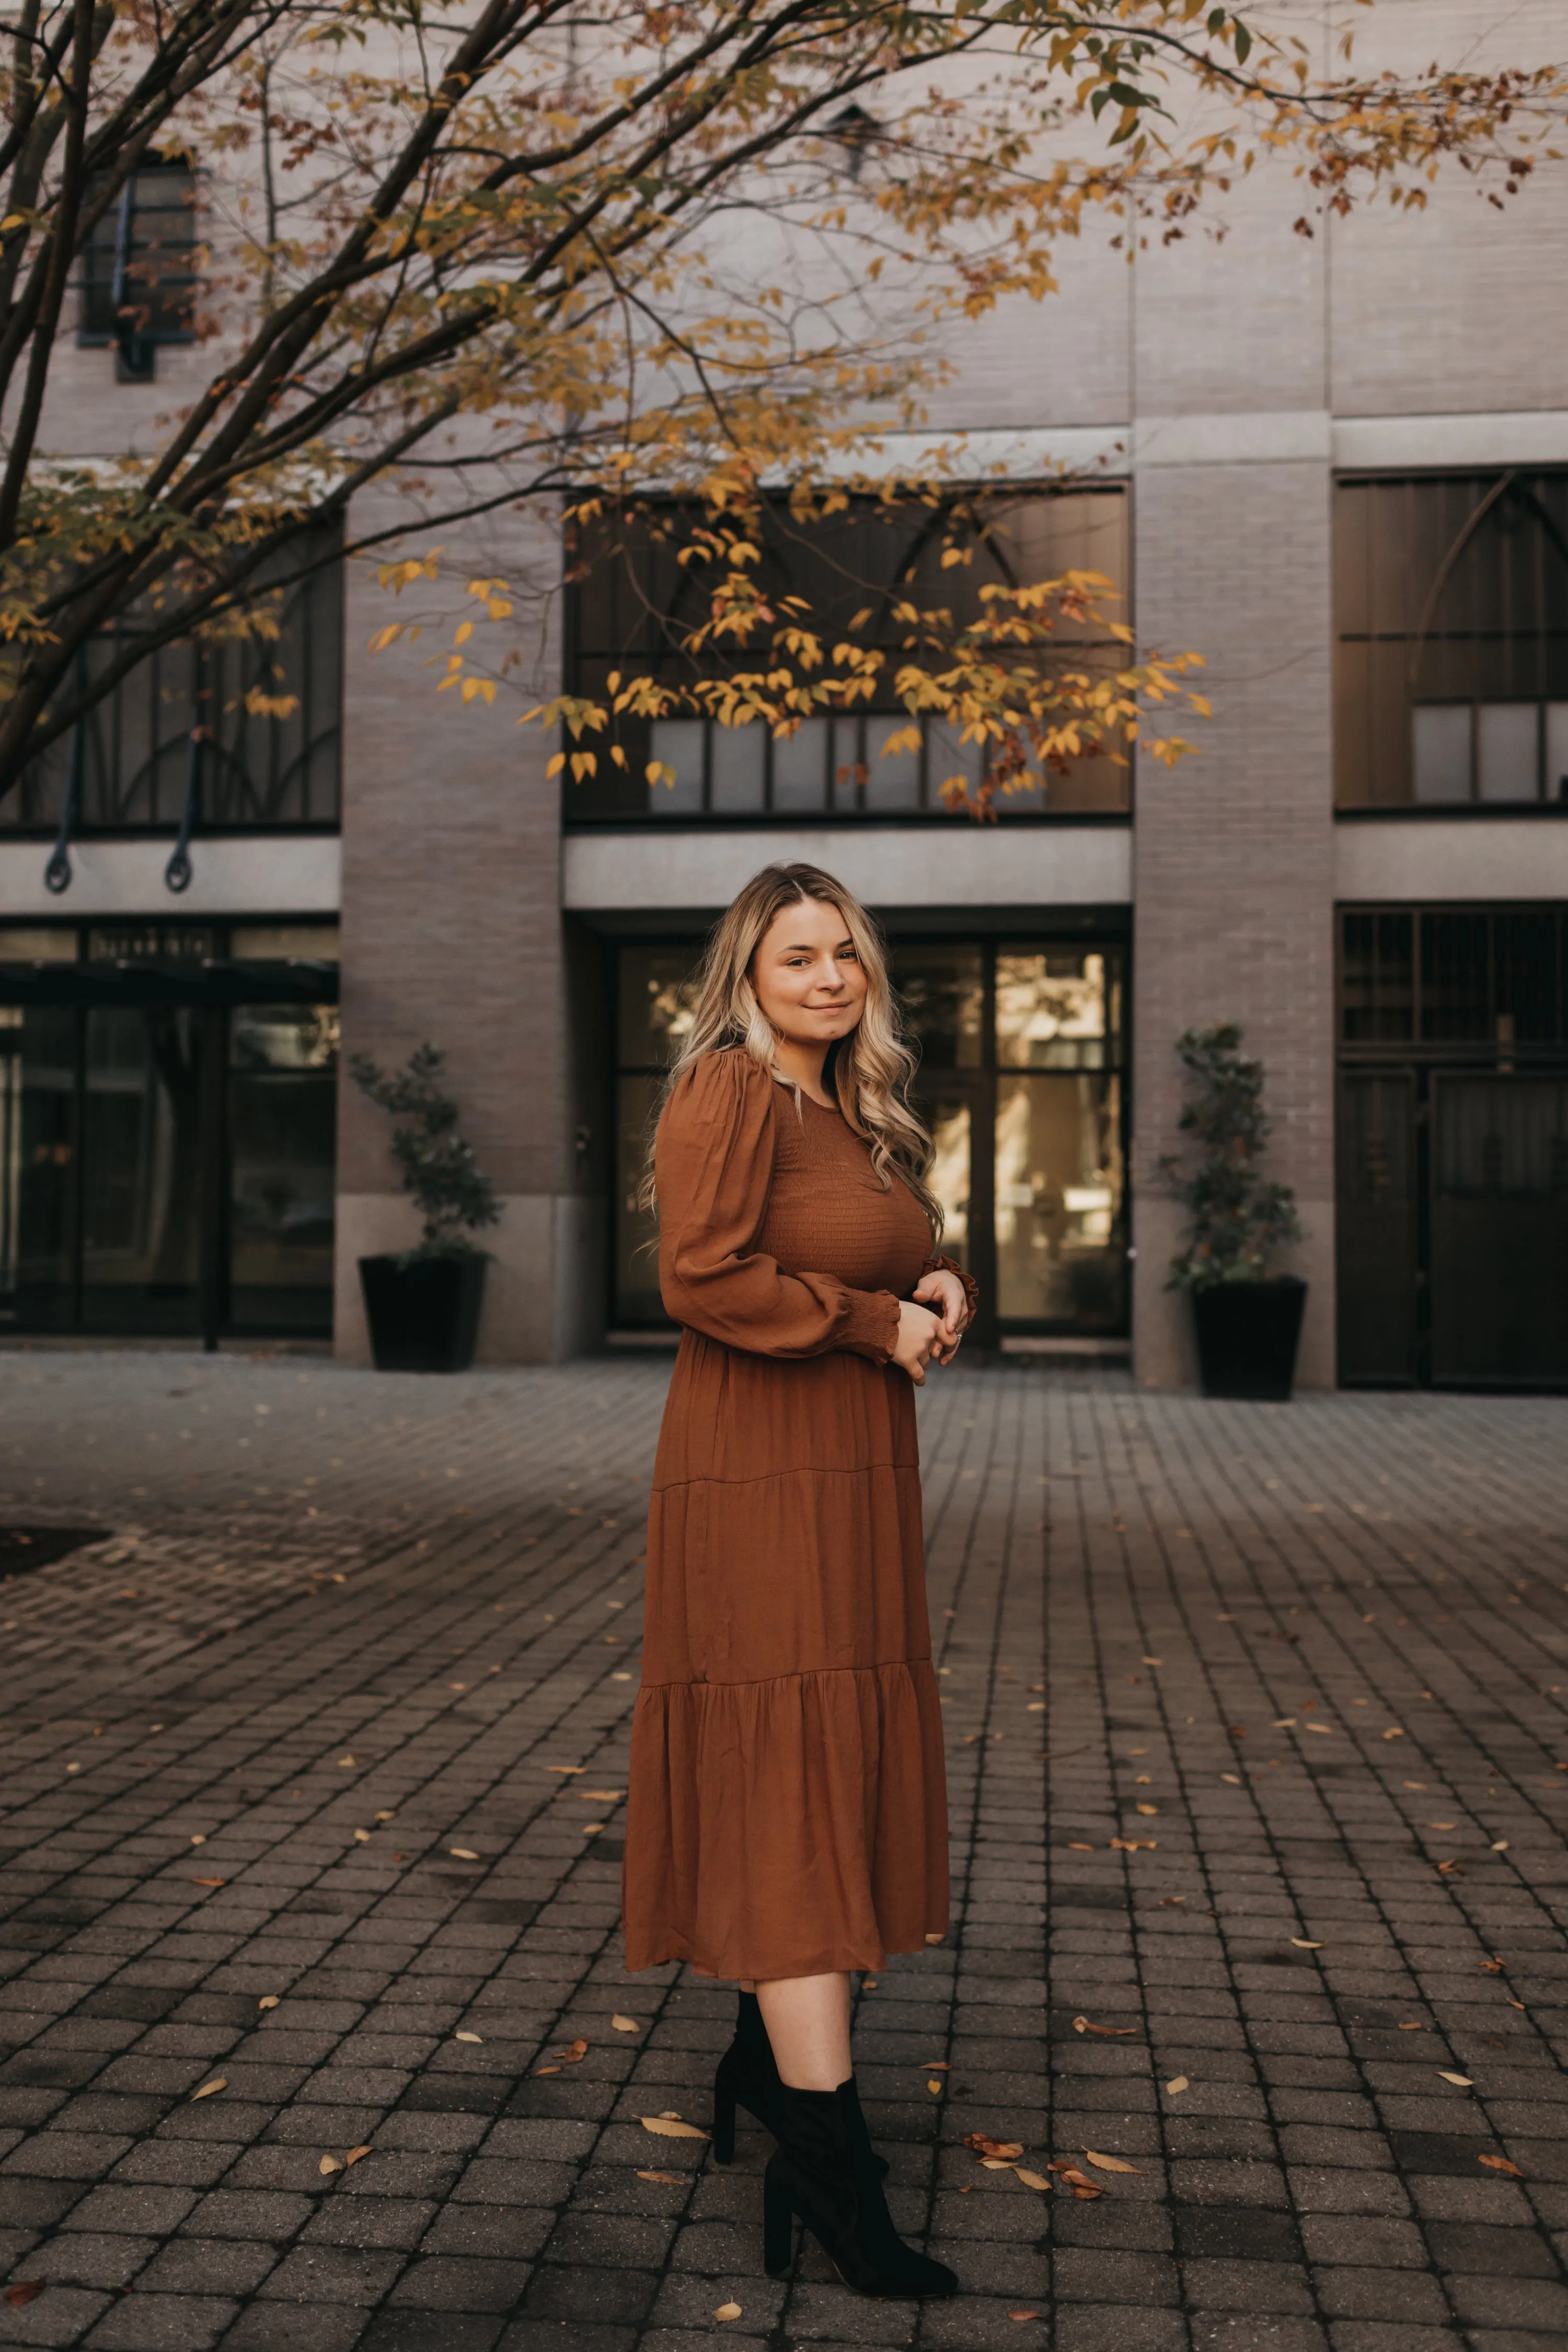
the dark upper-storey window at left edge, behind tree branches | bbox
[0,532,343,833]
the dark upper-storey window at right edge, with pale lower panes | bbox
[1335,468,1568,807]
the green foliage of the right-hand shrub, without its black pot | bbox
[1159,1021,1302,1292]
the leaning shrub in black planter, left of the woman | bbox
[348,1044,501,1371]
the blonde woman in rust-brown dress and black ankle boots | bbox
[625,866,971,2296]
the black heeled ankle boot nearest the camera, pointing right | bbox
[762,2074,959,2296]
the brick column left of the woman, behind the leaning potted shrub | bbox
[336,503,604,1364]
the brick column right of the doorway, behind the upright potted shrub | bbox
[1133,452,1335,1388]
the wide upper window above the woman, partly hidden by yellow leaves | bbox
[564,485,1131,823]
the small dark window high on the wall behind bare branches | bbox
[77,158,195,381]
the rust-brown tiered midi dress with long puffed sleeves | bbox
[623,1049,957,1978]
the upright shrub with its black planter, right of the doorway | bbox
[1159,1021,1307,1404]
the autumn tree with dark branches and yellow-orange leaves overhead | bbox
[0,0,1563,788]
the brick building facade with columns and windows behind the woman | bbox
[0,0,1568,1386]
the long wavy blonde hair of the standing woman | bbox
[639,866,943,1240]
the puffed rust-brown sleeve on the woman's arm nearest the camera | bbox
[653,1049,898,1364]
